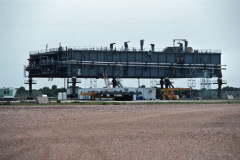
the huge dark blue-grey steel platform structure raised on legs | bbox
[26,39,224,98]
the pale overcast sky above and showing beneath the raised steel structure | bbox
[0,0,240,88]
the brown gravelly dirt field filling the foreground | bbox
[0,104,240,160]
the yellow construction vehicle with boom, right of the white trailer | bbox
[160,88,190,100]
